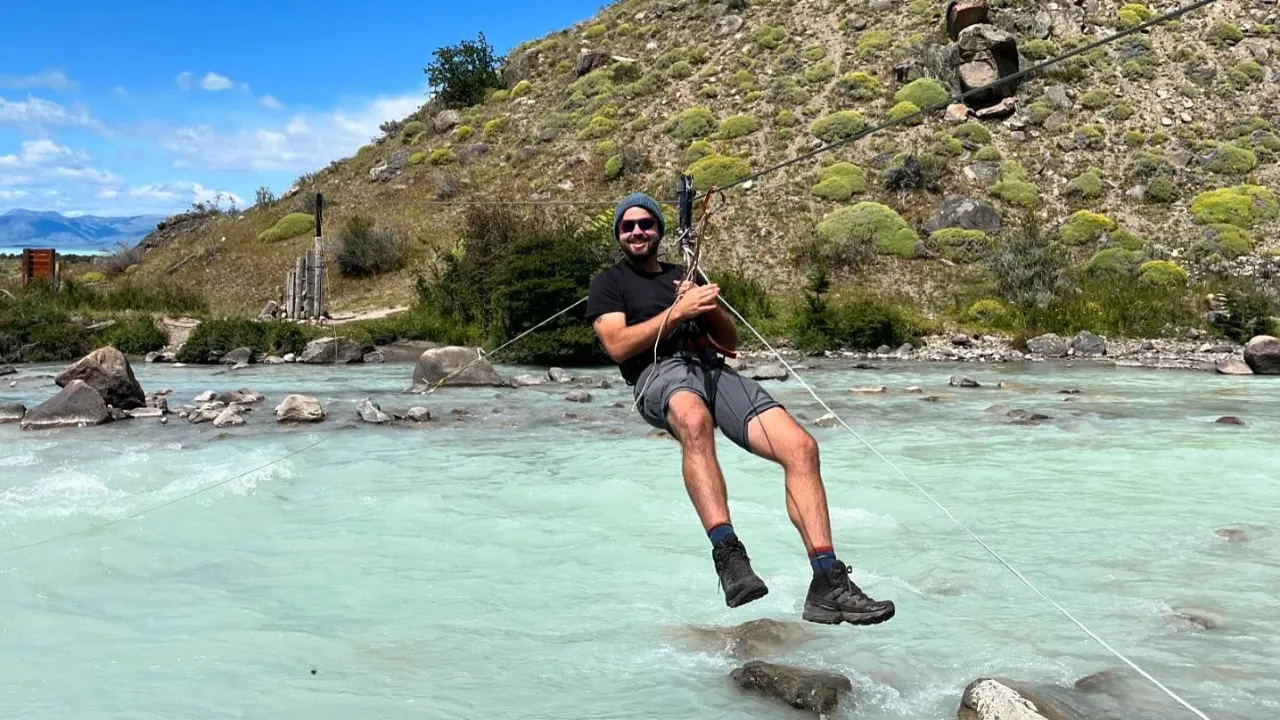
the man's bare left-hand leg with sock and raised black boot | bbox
[667,389,769,607]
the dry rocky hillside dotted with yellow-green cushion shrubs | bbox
[115,0,1280,326]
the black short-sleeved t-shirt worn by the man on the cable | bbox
[586,260,707,384]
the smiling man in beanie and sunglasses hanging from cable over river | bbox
[586,193,895,625]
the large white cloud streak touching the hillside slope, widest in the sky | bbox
[160,95,424,173]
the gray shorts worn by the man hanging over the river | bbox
[632,354,782,452]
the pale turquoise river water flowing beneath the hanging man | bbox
[0,363,1280,720]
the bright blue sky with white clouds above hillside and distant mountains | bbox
[0,0,605,215]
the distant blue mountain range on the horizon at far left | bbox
[0,210,165,252]
